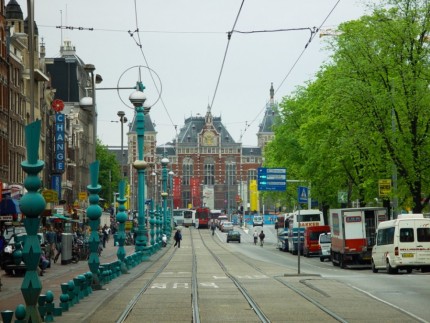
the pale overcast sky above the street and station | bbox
[21,0,376,146]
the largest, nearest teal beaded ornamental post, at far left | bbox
[20,120,46,322]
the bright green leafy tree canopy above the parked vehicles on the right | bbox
[265,0,430,212]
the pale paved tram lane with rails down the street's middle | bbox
[108,228,422,323]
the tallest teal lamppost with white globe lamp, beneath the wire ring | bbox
[129,86,151,260]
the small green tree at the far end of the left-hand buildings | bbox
[96,140,121,206]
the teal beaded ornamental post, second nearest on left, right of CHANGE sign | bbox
[87,160,102,289]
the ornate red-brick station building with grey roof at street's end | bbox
[146,84,278,213]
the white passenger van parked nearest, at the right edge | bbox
[372,214,430,274]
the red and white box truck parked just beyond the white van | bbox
[329,207,388,268]
